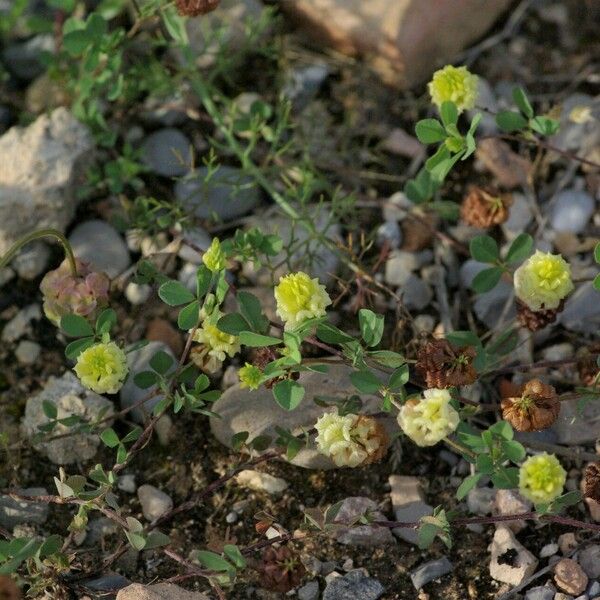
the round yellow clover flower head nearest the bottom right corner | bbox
[519,452,567,504]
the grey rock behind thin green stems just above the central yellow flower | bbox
[243,206,341,285]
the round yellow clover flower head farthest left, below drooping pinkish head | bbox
[74,342,129,394]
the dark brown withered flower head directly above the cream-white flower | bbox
[415,340,477,389]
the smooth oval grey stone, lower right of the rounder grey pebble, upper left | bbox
[175,165,260,221]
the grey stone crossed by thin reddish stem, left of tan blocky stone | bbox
[334,496,394,546]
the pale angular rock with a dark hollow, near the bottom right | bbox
[490,526,538,585]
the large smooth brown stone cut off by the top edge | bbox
[279,0,510,86]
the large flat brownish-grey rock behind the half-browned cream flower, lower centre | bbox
[210,366,397,469]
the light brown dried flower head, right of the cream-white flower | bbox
[501,379,560,431]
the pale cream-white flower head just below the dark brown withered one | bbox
[398,388,460,446]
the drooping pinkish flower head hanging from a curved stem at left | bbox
[40,259,110,325]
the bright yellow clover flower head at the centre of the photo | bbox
[275,271,331,329]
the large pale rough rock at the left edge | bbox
[0,108,93,254]
